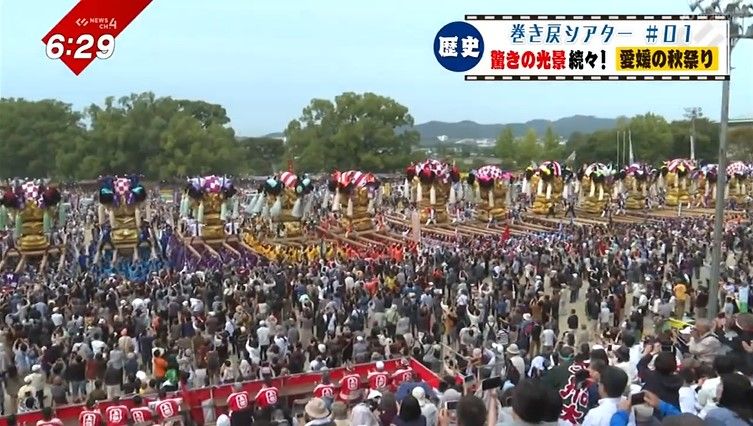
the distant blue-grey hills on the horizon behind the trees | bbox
[265,115,617,145]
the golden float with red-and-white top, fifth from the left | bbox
[324,170,381,233]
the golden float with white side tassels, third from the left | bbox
[180,175,239,257]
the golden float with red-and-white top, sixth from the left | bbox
[403,159,460,224]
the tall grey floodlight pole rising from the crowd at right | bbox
[690,0,753,319]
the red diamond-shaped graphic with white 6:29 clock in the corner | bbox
[42,0,152,75]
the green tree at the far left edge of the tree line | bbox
[0,98,87,178]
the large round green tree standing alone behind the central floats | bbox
[285,92,420,172]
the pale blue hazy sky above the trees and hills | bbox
[0,0,753,136]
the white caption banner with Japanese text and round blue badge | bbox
[434,15,729,81]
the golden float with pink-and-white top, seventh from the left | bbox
[467,165,513,222]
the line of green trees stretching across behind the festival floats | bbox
[0,92,753,180]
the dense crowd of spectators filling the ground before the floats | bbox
[0,183,753,426]
